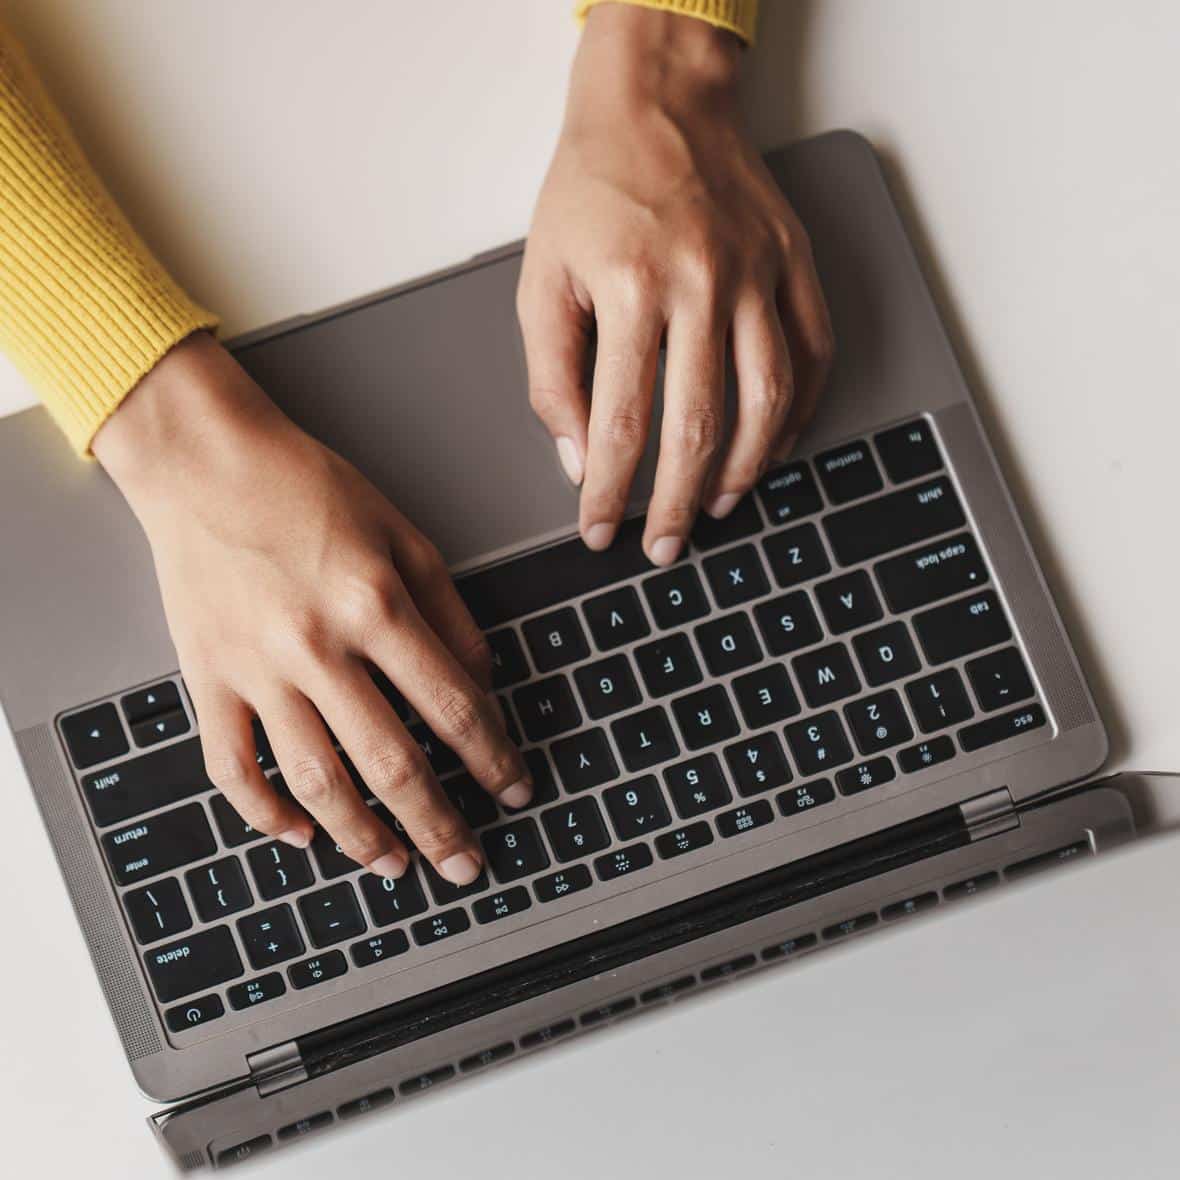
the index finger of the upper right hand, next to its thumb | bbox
[579,299,662,549]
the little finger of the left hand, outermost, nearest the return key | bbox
[185,680,314,848]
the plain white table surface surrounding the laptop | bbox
[0,0,1180,1180]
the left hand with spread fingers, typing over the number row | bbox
[93,333,532,885]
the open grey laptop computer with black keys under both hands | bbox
[0,132,1134,1168]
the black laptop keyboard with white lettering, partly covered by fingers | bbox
[60,419,1047,1033]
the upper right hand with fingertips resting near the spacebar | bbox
[517,4,833,565]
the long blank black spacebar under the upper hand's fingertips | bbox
[455,517,651,631]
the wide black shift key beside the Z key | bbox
[824,476,964,565]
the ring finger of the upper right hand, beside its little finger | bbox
[704,288,793,519]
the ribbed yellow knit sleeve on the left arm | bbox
[0,26,216,454]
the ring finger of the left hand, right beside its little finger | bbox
[257,681,409,877]
